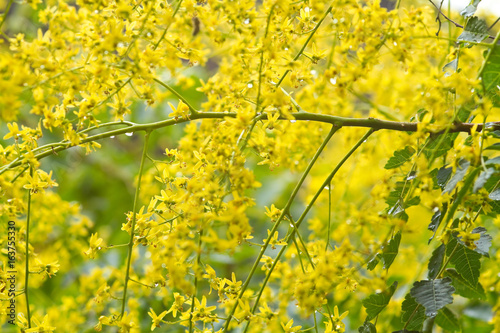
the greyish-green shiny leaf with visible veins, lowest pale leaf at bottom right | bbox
[410,277,455,317]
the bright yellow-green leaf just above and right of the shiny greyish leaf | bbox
[446,237,481,286]
